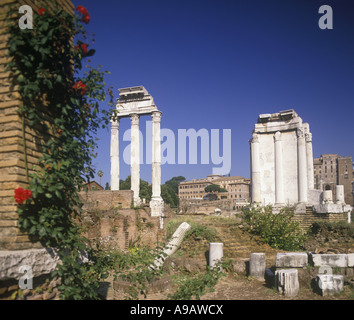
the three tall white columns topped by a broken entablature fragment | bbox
[111,86,164,217]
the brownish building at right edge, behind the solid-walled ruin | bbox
[313,154,354,206]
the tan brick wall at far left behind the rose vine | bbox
[0,0,74,250]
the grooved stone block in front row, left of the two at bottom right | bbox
[275,269,300,297]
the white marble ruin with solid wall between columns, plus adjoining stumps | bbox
[250,109,352,220]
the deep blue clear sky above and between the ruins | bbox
[73,0,354,185]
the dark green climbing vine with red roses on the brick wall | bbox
[8,0,113,299]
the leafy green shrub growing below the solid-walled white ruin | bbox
[243,205,305,250]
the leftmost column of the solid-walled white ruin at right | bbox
[250,133,261,203]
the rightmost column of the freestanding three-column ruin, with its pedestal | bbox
[150,111,164,217]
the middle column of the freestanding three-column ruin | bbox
[130,113,141,206]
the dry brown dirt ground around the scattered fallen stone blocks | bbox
[103,217,354,301]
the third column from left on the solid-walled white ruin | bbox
[297,128,307,203]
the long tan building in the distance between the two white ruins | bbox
[178,175,250,206]
